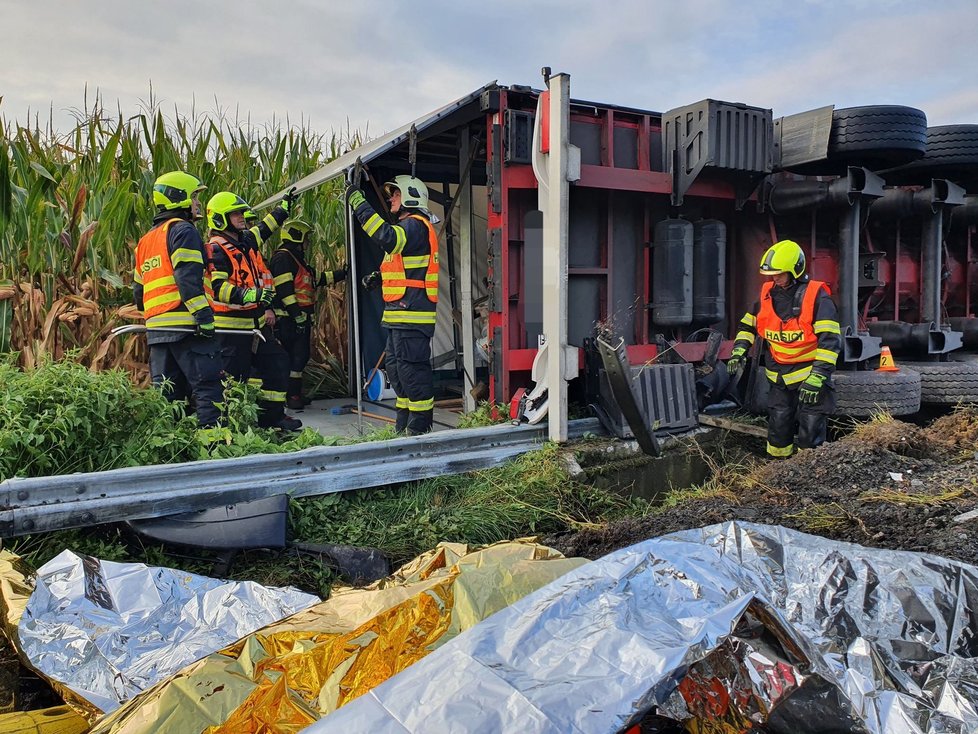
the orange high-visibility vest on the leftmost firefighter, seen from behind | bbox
[136,218,214,329]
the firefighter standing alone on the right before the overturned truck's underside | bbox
[727,240,842,458]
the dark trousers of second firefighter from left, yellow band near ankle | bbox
[218,326,289,428]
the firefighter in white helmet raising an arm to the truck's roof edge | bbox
[347,175,438,435]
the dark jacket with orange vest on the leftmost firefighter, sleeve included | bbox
[133,216,214,343]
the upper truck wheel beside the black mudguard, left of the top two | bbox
[829,105,927,169]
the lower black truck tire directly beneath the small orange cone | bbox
[832,365,920,418]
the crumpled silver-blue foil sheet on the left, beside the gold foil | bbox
[17,551,319,714]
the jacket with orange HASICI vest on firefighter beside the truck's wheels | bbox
[735,280,842,386]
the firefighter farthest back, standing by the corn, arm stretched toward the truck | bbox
[269,219,346,410]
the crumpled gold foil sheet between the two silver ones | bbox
[92,541,586,734]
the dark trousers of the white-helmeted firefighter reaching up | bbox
[384,329,435,436]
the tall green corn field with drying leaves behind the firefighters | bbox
[0,97,357,396]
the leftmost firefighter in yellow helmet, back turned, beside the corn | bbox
[132,171,223,429]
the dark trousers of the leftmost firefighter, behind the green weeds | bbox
[149,336,224,428]
